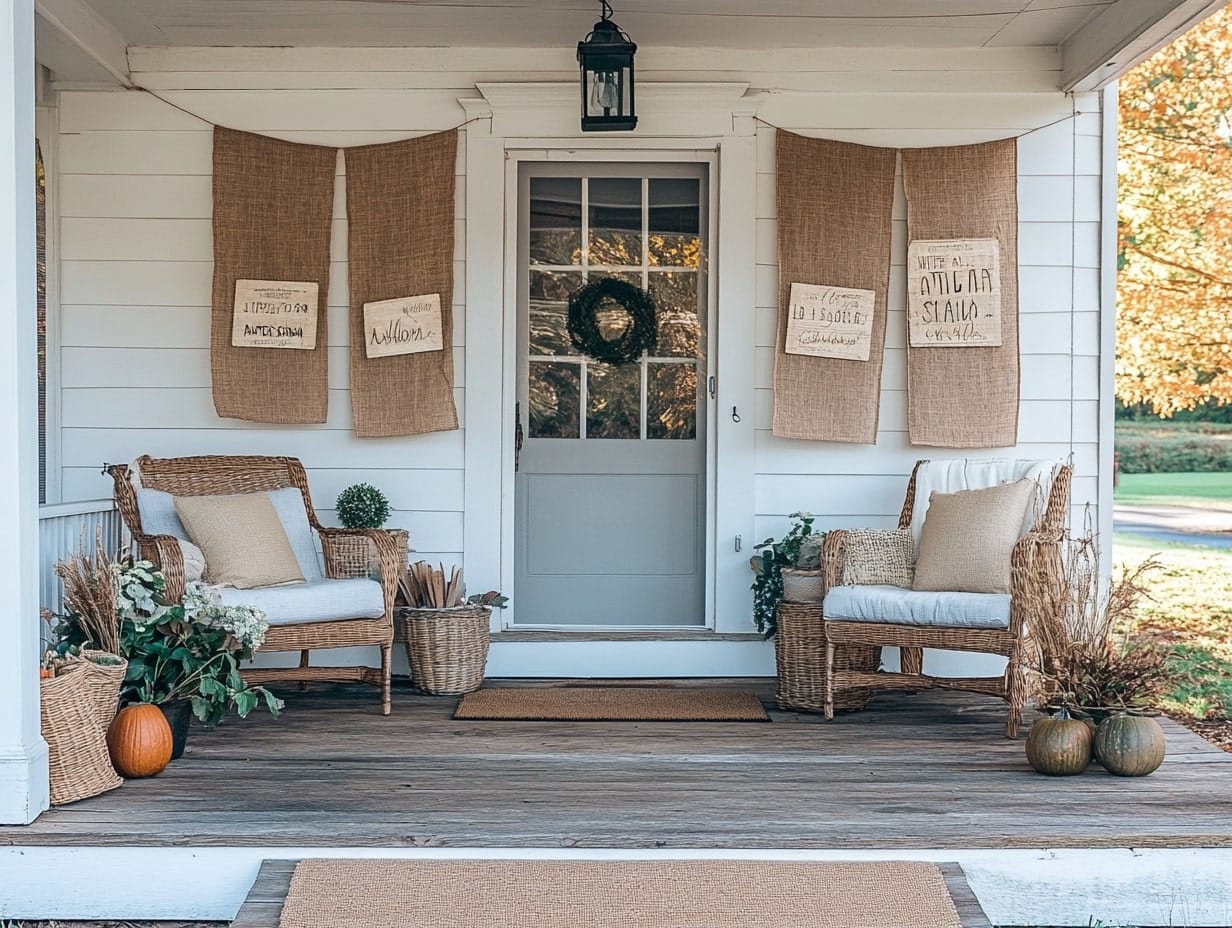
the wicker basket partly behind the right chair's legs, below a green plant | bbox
[774,603,881,712]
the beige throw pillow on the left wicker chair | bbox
[175,493,304,589]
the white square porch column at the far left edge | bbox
[0,0,48,824]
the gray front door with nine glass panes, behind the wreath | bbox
[514,164,707,627]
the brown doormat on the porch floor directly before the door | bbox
[453,686,770,722]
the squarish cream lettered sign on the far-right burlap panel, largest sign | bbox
[907,238,1002,348]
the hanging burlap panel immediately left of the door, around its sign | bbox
[345,129,458,438]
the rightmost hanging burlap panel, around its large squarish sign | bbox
[903,138,1019,447]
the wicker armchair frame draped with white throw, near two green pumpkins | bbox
[822,461,1071,738]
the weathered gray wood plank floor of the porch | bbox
[0,682,1232,848]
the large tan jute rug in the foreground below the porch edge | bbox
[280,859,962,928]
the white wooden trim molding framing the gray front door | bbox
[458,81,764,640]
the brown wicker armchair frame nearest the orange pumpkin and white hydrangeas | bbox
[107,455,402,715]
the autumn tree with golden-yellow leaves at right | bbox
[1116,9,1232,415]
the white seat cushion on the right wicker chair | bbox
[822,585,1009,629]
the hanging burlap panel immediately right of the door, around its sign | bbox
[774,131,897,442]
